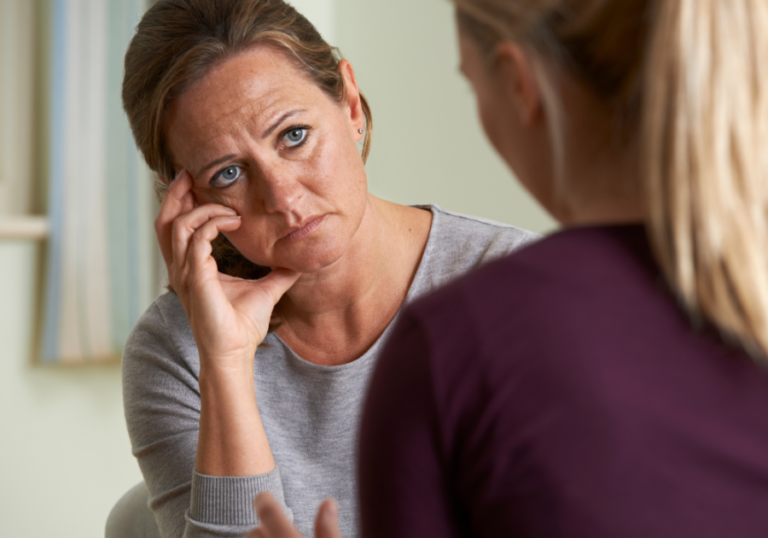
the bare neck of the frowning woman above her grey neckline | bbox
[276,195,431,365]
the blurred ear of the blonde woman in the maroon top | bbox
[496,41,543,125]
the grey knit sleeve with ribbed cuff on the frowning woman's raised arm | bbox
[123,297,292,538]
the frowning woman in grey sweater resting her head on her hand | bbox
[117,0,535,538]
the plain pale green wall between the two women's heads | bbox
[336,0,554,232]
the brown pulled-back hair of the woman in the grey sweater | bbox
[123,0,373,278]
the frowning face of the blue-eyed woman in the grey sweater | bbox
[166,45,368,272]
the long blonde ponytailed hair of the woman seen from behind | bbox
[453,0,768,364]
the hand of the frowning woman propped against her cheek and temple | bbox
[155,171,299,370]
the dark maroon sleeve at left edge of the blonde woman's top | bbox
[358,311,458,538]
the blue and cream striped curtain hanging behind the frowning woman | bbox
[40,0,158,363]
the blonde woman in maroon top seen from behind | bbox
[250,0,768,538]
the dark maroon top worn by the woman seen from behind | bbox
[359,226,768,538]
